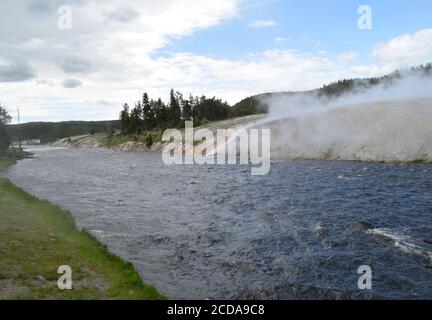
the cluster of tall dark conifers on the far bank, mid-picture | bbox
[120,89,233,135]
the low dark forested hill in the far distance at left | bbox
[7,120,120,143]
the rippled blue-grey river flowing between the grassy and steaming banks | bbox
[6,148,432,299]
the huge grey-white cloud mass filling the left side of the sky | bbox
[0,0,239,120]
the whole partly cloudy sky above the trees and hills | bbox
[0,0,432,122]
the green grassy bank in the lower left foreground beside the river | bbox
[0,152,163,299]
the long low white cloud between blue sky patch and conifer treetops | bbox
[149,50,369,103]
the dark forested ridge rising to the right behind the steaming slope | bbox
[230,63,432,117]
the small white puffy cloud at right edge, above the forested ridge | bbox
[372,29,432,69]
